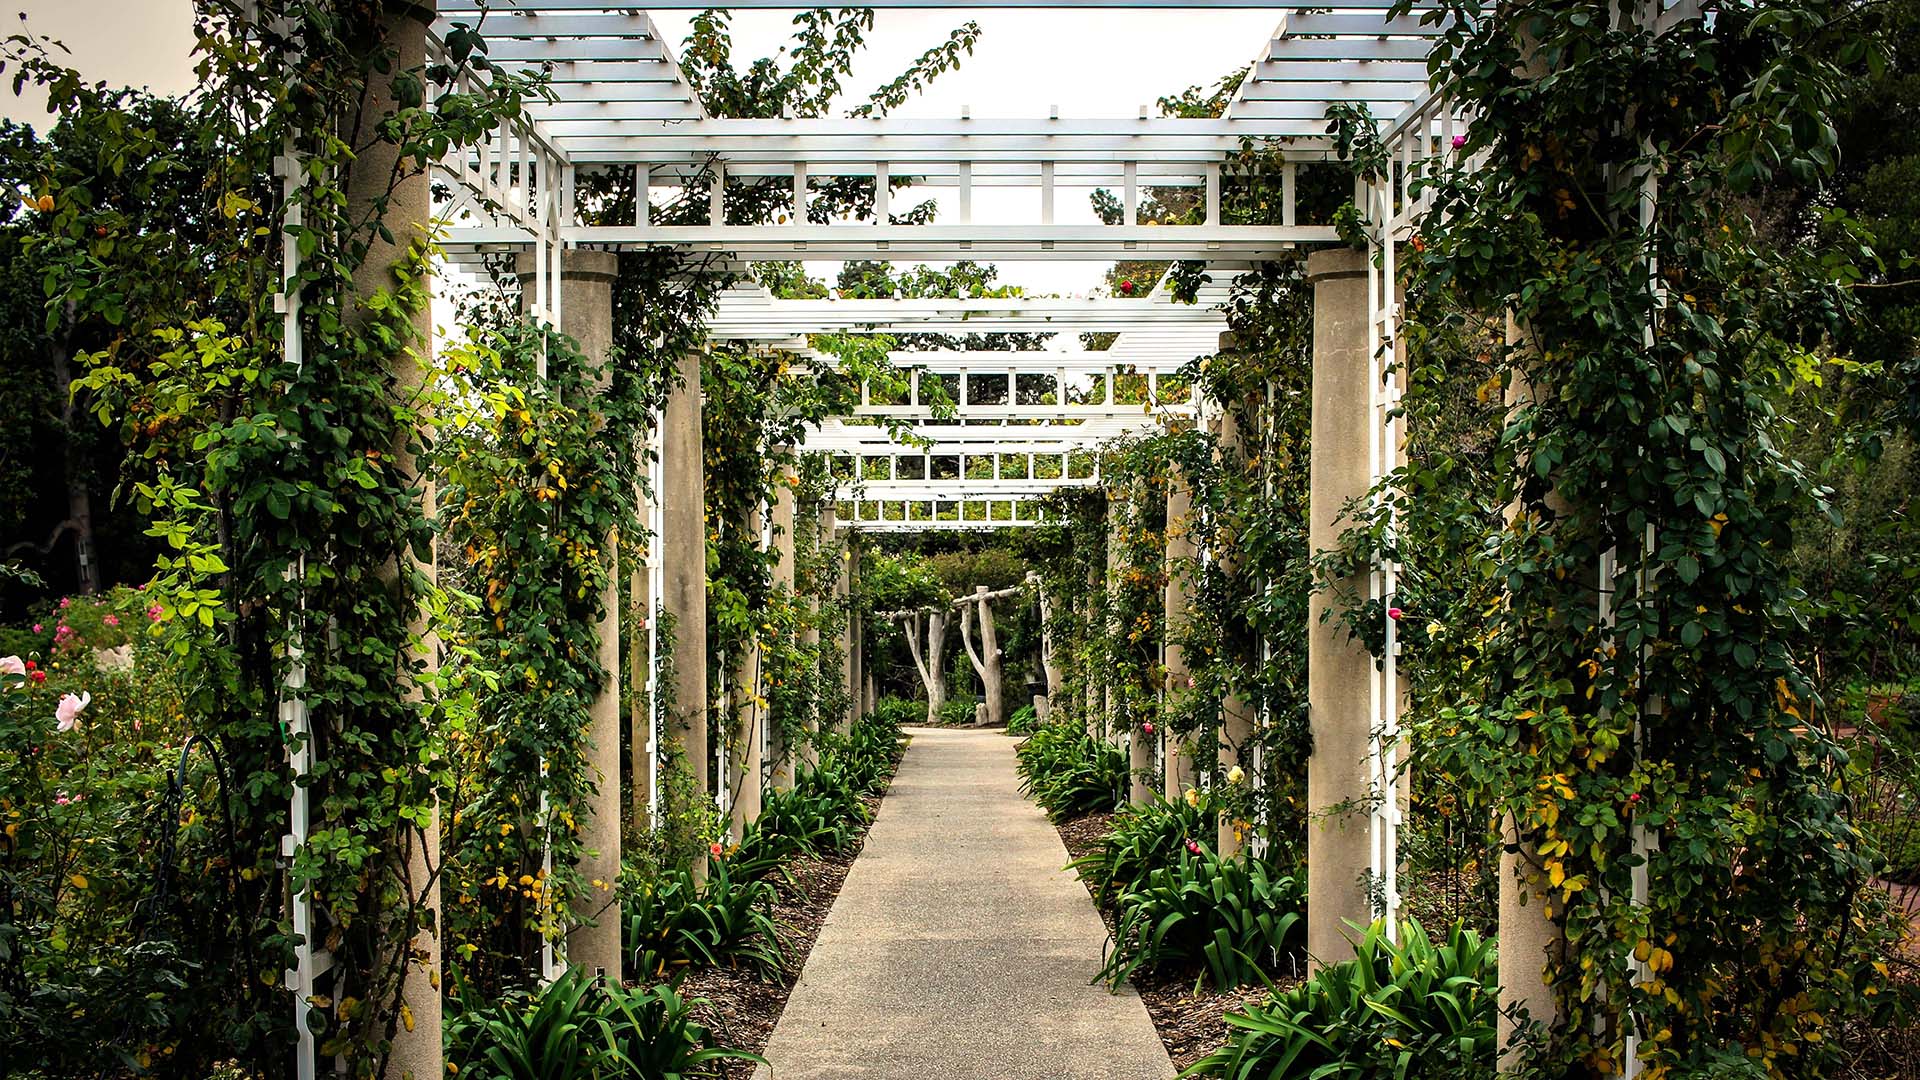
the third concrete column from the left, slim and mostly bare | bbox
[660,352,712,876]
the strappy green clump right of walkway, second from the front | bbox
[1100,840,1304,990]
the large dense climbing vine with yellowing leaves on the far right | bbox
[1328,2,1896,1076]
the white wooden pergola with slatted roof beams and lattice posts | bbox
[284,0,1528,1076]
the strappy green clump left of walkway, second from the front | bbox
[624,857,787,980]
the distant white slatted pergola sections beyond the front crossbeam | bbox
[708,274,1213,532]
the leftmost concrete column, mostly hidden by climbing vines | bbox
[346,0,445,1080]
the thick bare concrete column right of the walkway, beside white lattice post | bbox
[1308,248,1377,965]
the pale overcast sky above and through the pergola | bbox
[0,0,1279,292]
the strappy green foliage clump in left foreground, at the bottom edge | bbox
[447,969,760,1080]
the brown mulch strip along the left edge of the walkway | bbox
[680,796,879,1080]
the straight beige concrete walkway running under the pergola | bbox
[756,728,1173,1080]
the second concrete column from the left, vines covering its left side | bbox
[518,250,620,978]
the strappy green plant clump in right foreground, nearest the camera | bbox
[1181,922,1500,1080]
